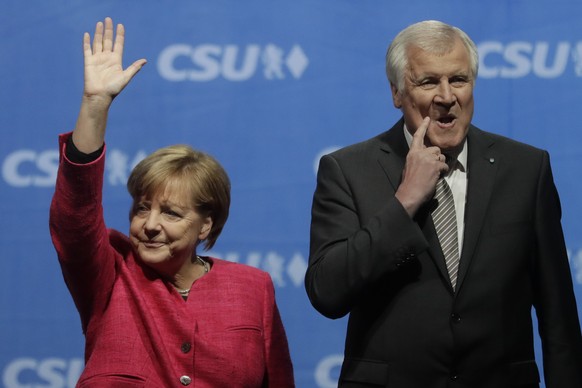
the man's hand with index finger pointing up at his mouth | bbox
[395,117,449,217]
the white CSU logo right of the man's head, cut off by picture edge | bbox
[478,41,582,78]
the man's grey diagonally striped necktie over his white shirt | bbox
[432,178,459,290]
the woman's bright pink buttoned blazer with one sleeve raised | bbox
[50,134,294,388]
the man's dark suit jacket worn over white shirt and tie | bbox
[306,120,582,388]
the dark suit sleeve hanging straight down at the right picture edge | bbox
[534,151,582,388]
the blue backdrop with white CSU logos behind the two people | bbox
[0,0,582,388]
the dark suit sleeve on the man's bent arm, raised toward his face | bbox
[305,155,428,318]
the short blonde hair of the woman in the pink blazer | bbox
[127,145,230,250]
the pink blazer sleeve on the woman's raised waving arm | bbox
[49,133,115,332]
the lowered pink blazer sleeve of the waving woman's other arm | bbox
[263,273,295,388]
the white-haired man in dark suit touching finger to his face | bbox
[306,21,582,388]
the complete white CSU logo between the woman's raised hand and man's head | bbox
[157,43,309,82]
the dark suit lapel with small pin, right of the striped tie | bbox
[457,126,500,292]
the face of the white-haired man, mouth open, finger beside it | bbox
[391,39,474,151]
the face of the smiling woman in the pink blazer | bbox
[129,185,212,276]
